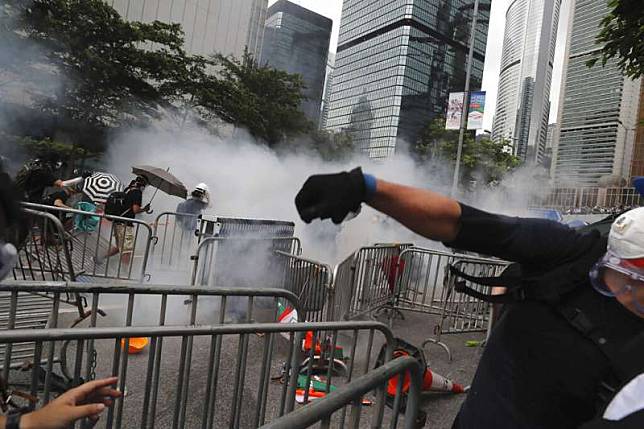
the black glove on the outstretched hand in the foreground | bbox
[295,167,367,224]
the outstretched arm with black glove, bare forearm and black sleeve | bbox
[295,169,594,265]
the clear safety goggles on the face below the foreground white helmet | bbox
[590,251,644,314]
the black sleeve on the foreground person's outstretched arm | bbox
[445,204,599,266]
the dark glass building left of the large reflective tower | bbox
[261,0,333,124]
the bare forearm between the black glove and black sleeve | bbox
[367,180,461,242]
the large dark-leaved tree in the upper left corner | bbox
[17,0,209,127]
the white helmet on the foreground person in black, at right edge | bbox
[608,207,644,259]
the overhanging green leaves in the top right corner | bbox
[587,0,644,79]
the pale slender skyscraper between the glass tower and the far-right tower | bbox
[492,0,561,164]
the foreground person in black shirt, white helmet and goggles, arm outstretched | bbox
[295,169,644,429]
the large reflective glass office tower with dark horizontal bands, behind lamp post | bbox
[326,0,489,158]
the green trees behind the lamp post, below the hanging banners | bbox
[411,117,520,184]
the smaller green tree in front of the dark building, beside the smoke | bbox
[194,51,313,147]
